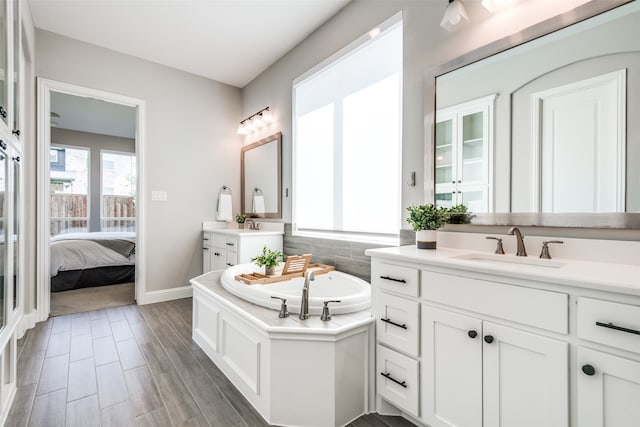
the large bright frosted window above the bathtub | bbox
[293,14,402,244]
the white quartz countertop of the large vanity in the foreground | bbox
[365,245,640,296]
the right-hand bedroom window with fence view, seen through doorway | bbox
[100,151,136,231]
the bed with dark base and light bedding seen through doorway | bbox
[50,232,136,292]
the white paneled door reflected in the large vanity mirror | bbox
[533,70,626,216]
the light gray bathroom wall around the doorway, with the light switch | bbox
[36,30,241,291]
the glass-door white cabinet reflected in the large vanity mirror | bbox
[435,95,495,213]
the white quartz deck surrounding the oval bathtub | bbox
[190,271,374,336]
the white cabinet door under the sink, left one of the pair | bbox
[422,305,482,427]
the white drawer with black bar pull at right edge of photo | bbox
[578,297,640,353]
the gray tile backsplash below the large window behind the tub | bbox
[284,224,415,282]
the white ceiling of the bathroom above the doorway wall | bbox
[29,0,350,88]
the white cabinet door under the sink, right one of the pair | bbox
[483,322,569,427]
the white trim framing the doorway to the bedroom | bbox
[36,77,147,321]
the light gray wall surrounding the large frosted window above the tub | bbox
[242,0,586,228]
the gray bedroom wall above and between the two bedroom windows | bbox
[51,128,136,231]
